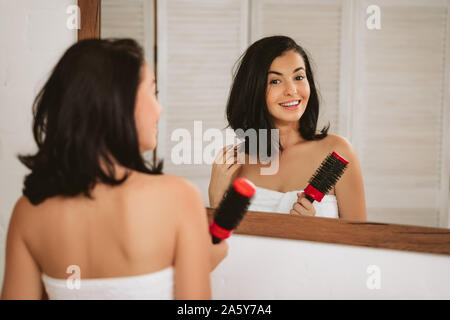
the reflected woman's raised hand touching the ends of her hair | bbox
[208,145,242,208]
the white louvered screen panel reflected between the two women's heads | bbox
[157,0,248,202]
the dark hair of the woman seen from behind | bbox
[18,39,162,205]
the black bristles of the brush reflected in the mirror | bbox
[309,154,347,194]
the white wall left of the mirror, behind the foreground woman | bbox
[0,0,77,287]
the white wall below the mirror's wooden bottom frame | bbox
[211,235,450,300]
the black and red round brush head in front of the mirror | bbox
[209,178,255,243]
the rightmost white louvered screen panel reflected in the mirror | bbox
[353,0,450,227]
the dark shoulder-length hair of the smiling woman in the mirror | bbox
[226,36,330,156]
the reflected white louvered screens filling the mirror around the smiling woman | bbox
[101,0,450,228]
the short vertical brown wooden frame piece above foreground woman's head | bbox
[78,0,101,40]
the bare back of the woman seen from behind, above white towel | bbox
[20,172,177,278]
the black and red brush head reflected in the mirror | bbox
[305,152,348,202]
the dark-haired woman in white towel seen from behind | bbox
[2,39,227,299]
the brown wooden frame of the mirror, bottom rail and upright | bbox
[78,0,450,255]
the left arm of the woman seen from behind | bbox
[1,197,45,300]
